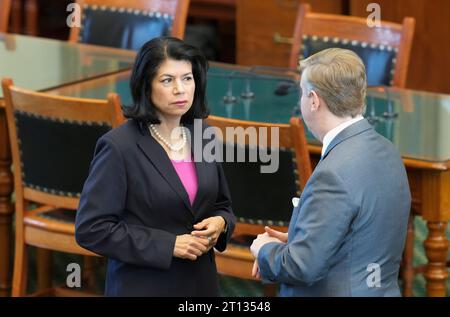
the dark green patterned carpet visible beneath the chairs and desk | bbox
[29,217,450,297]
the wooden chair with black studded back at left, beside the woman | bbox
[2,79,124,296]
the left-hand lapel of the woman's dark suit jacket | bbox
[137,123,193,213]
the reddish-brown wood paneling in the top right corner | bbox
[349,0,450,93]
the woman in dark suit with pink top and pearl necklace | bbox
[75,37,235,296]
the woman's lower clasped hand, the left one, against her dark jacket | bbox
[173,234,209,261]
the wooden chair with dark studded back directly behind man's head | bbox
[290,4,415,88]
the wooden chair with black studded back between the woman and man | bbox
[206,116,312,295]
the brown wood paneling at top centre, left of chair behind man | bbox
[236,0,345,67]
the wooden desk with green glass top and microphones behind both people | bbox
[45,64,450,296]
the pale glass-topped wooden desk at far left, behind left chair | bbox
[0,33,135,296]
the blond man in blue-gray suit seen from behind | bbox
[251,48,411,296]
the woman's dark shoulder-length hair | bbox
[122,37,209,125]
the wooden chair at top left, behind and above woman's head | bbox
[69,0,189,50]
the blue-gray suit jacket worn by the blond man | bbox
[258,120,411,296]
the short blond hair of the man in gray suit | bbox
[300,48,367,117]
